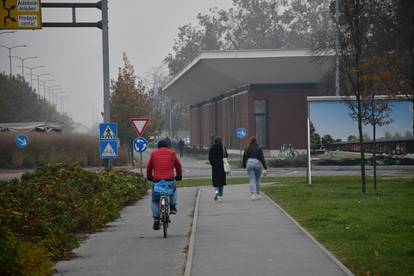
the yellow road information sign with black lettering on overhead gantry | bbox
[0,0,42,30]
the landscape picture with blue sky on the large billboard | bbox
[309,98,414,164]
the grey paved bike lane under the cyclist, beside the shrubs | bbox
[56,188,196,276]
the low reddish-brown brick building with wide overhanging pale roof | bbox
[163,50,334,150]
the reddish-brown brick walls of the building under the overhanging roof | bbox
[190,85,321,149]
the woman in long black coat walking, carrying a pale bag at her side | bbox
[208,137,228,201]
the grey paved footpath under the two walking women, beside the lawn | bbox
[192,185,347,276]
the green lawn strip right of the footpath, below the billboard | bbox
[264,177,414,275]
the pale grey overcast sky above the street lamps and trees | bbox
[0,0,232,126]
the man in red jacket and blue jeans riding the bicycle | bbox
[147,140,182,230]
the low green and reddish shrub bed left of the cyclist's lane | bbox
[0,163,148,275]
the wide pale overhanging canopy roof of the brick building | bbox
[163,50,335,104]
